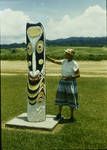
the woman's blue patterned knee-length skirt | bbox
[55,79,78,109]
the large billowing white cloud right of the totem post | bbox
[47,5,106,39]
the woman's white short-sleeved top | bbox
[61,59,79,77]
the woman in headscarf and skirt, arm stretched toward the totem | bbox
[48,49,80,122]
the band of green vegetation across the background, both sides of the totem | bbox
[1,45,107,60]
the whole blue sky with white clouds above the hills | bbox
[0,0,106,44]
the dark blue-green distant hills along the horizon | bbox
[0,37,107,48]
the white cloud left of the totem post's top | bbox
[0,9,30,43]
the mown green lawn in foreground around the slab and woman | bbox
[1,75,107,150]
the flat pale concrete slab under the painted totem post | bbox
[5,113,58,130]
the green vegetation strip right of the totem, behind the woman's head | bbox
[46,46,107,61]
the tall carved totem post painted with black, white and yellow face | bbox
[26,23,46,122]
